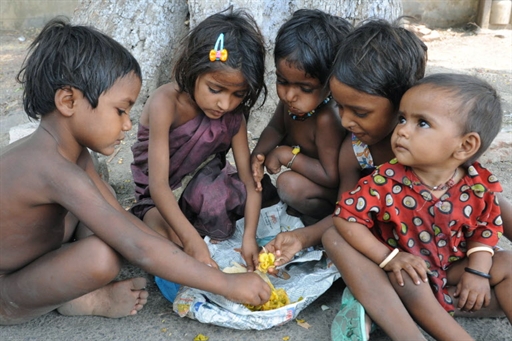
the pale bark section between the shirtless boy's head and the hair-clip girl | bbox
[72,0,189,114]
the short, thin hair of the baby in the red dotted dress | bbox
[416,73,503,166]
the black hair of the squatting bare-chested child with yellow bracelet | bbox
[274,9,353,85]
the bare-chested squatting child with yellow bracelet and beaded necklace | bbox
[251,9,352,219]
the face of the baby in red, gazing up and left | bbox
[391,84,463,167]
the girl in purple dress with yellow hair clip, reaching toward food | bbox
[131,9,266,271]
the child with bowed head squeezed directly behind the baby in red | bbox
[265,20,427,265]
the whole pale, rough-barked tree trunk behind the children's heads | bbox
[73,0,402,136]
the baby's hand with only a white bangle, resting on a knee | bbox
[384,252,429,286]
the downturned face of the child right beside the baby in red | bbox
[329,77,396,146]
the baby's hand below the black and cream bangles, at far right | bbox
[453,273,491,311]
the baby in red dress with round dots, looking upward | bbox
[328,74,512,340]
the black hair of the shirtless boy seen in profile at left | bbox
[16,17,142,119]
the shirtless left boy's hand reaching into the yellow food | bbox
[225,272,270,305]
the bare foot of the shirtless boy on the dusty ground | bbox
[57,277,148,318]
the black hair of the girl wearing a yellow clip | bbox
[173,7,267,115]
